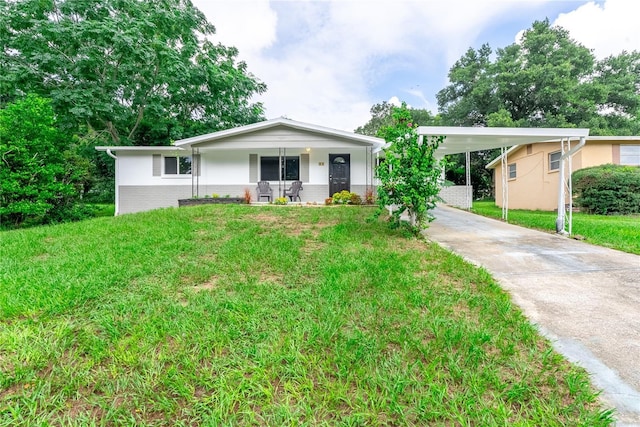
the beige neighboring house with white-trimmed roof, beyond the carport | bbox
[487,136,640,211]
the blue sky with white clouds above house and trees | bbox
[192,0,640,131]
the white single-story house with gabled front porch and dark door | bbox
[96,118,384,215]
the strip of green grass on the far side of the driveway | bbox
[472,200,640,255]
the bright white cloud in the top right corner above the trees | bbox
[554,0,640,59]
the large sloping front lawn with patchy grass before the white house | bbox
[0,205,612,426]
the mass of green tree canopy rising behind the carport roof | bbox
[437,20,640,135]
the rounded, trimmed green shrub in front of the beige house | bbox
[572,164,640,215]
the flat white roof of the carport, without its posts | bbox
[418,126,589,156]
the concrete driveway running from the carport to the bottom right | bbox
[425,206,640,426]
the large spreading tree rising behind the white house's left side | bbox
[0,0,265,145]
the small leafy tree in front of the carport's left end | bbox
[376,103,444,233]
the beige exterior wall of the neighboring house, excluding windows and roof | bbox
[493,140,640,211]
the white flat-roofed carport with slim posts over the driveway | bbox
[418,126,589,234]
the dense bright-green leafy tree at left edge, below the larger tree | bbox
[0,95,88,227]
